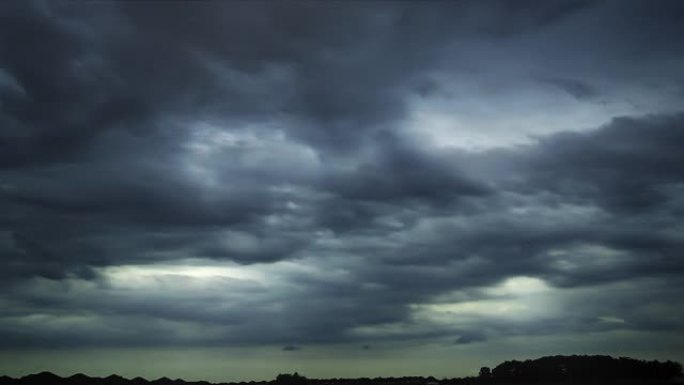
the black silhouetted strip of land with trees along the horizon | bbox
[0,355,684,385]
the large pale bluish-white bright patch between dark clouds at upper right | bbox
[403,80,678,151]
